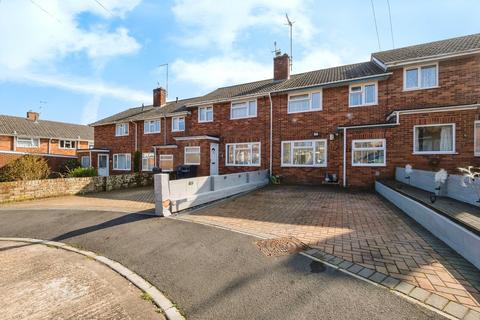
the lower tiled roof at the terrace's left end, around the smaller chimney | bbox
[91,98,199,126]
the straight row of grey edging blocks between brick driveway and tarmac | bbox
[300,249,480,319]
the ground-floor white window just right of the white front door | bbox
[225,142,261,167]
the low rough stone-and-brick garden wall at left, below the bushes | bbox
[0,173,153,203]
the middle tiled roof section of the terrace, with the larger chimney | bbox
[189,61,385,105]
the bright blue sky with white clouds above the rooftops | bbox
[0,0,480,123]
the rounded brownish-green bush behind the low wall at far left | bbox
[0,155,50,181]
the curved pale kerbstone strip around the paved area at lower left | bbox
[0,237,185,320]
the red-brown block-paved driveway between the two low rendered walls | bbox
[178,186,480,310]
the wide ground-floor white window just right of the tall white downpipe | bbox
[282,139,327,167]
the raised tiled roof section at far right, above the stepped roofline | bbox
[372,33,480,64]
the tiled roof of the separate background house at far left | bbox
[0,115,93,140]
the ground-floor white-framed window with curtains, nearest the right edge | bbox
[413,123,455,154]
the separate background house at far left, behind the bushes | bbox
[0,111,94,171]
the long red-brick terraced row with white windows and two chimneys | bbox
[89,34,480,186]
